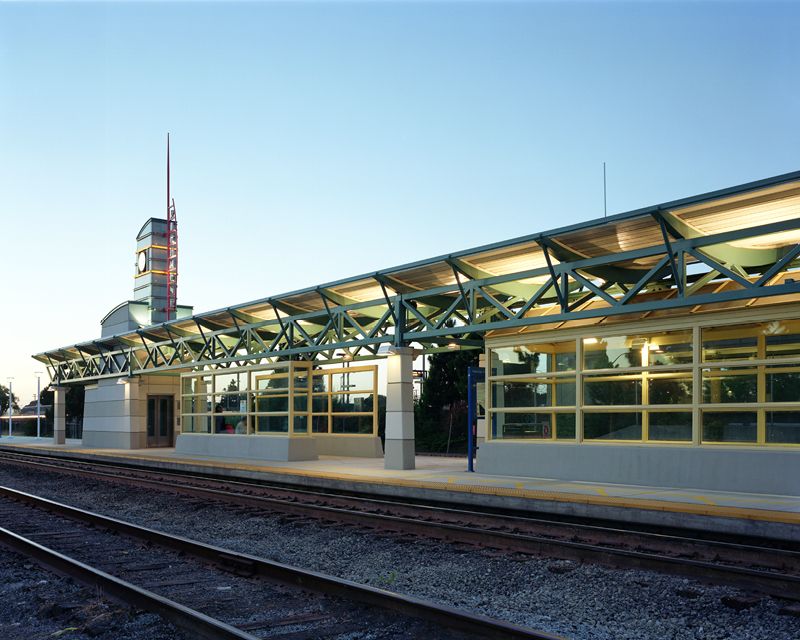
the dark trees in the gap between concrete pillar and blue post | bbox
[414,349,480,453]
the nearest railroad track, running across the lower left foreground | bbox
[0,487,563,640]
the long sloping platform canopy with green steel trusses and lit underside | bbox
[34,172,800,382]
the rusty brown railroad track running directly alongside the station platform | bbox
[1,450,800,601]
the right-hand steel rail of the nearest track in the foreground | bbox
[0,487,565,640]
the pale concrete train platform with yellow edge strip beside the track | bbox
[0,436,800,541]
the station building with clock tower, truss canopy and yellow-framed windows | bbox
[34,172,800,495]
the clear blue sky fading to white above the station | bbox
[0,1,800,403]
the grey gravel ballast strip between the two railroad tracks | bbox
[0,466,800,640]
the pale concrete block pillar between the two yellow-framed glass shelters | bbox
[384,347,415,469]
